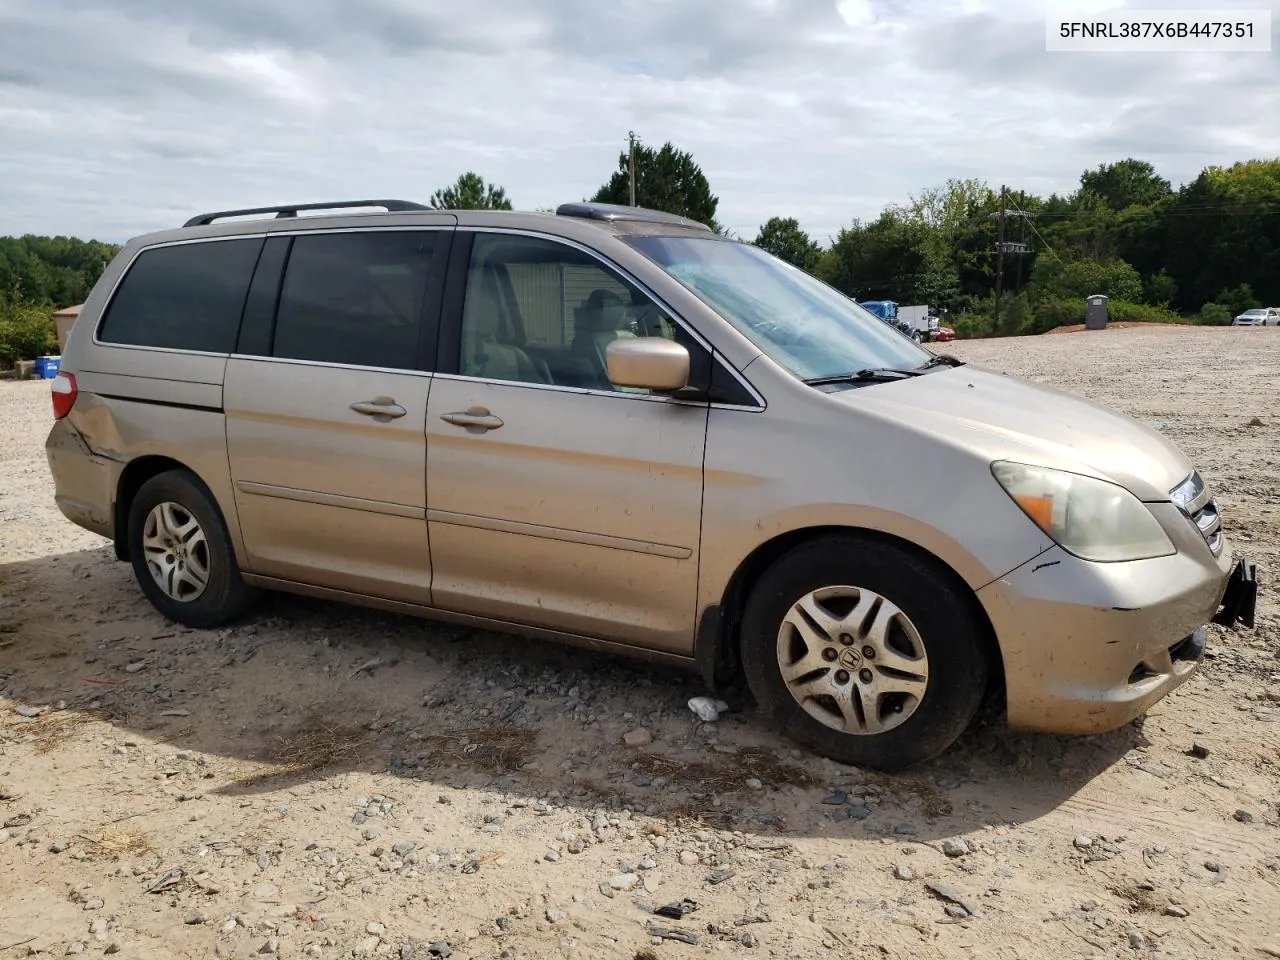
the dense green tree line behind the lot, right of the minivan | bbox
[793,157,1280,337]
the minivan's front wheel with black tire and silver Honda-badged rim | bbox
[741,536,991,771]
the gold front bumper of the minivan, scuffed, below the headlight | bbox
[978,521,1257,733]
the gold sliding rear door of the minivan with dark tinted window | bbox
[224,229,451,604]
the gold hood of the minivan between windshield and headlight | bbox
[831,364,1193,502]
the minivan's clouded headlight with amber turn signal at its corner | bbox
[991,461,1176,563]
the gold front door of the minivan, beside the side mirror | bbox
[426,233,708,654]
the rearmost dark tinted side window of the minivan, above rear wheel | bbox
[97,237,262,353]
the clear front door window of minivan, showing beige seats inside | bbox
[458,233,695,393]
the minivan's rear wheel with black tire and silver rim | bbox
[128,470,252,630]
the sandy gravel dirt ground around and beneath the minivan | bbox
[0,328,1280,960]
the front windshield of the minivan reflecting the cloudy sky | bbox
[627,237,933,380]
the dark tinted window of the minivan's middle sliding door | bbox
[271,230,442,370]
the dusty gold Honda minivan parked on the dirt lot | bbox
[47,201,1257,769]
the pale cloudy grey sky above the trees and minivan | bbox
[0,0,1280,242]
